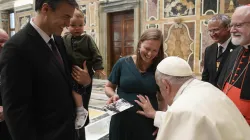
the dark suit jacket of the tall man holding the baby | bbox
[0,24,75,140]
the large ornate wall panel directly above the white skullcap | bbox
[164,22,195,69]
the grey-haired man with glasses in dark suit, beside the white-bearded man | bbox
[202,14,236,86]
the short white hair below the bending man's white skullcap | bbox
[155,70,194,85]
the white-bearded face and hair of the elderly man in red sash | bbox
[231,9,250,46]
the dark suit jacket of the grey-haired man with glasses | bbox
[202,41,236,86]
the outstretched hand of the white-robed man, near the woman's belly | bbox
[135,95,156,119]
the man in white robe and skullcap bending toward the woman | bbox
[136,56,250,140]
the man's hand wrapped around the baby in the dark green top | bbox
[71,61,91,86]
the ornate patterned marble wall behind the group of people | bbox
[0,0,246,75]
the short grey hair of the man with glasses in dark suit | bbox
[208,14,231,27]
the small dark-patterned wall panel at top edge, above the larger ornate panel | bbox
[163,0,195,18]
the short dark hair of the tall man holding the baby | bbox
[35,0,78,11]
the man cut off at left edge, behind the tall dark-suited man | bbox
[0,28,11,140]
